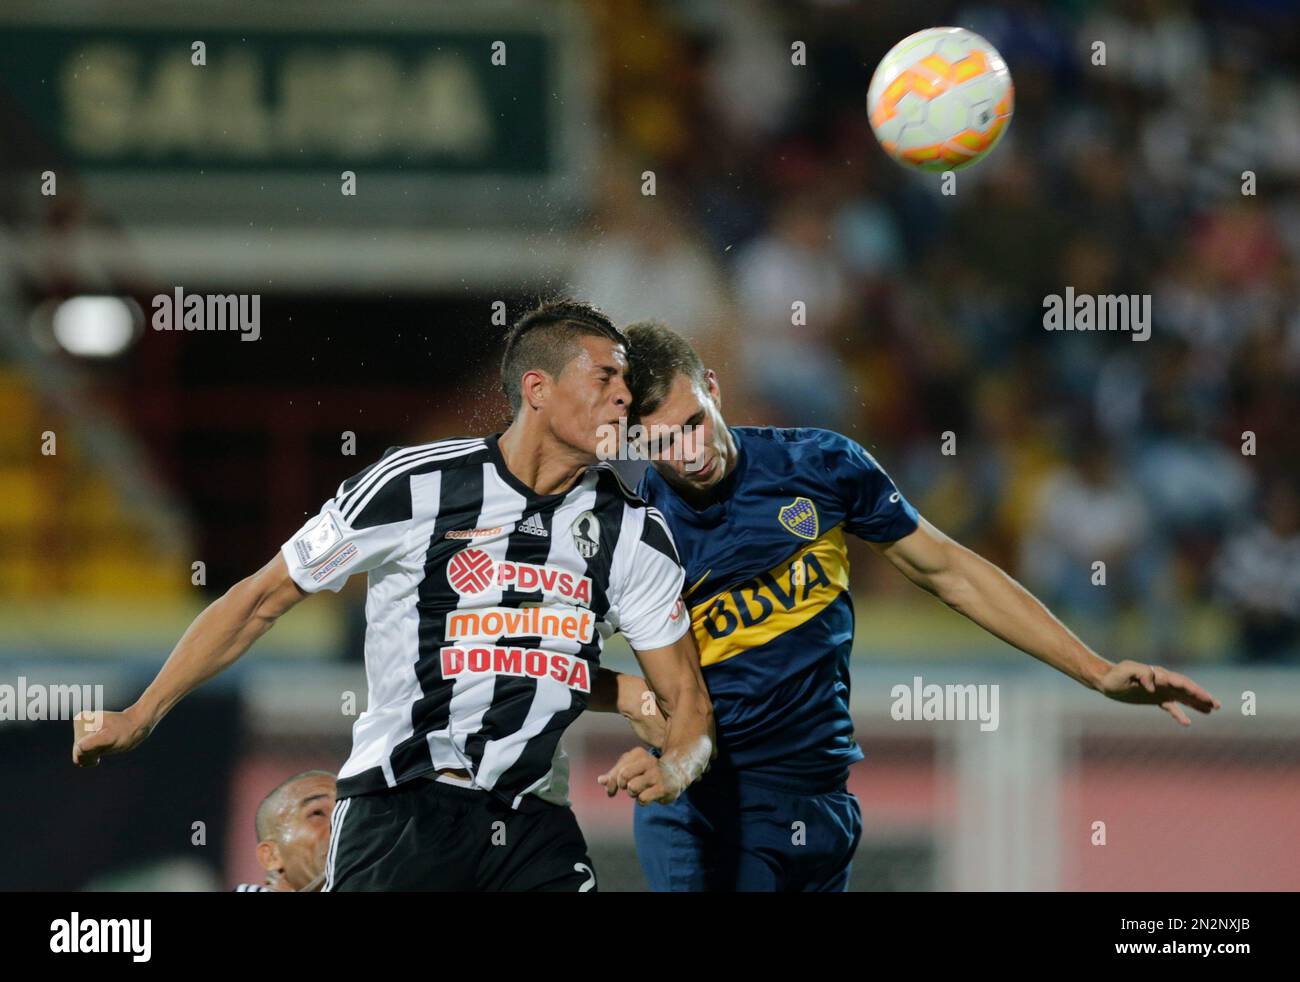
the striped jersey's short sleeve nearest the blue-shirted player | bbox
[619,509,690,652]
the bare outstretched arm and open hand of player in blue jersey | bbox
[871,519,1219,726]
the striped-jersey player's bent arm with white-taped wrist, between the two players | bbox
[597,631,716,805]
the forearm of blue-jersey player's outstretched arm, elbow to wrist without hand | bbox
[932,544,1110,688]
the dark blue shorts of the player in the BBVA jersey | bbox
[633,773,862,892]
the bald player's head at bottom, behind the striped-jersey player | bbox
[254,770,338,891]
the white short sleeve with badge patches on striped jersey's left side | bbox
[280,452,411,593]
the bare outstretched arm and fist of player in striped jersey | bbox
[73,553,307,767]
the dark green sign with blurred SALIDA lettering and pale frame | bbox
[0,1,590,225]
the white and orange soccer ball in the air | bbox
[867,27,1014,170]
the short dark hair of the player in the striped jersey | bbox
[501,298,628,412]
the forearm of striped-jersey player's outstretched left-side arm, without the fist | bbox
[127,577,280,730]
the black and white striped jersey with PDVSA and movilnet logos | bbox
[281,434,689,806]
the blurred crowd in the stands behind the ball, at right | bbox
[571,0,1300,661]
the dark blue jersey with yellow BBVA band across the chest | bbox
[640,427,918,792]
